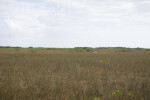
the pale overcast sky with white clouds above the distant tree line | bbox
[0,0,150,48]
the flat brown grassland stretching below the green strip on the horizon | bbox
[0,50,150,100]
